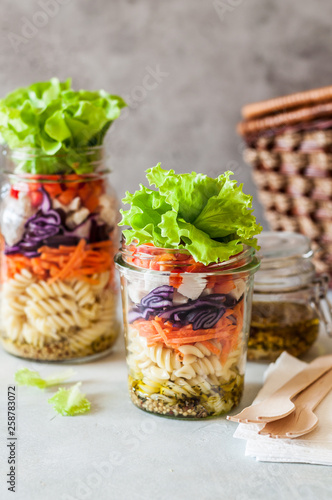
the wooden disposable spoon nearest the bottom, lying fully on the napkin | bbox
[258,370,332,438]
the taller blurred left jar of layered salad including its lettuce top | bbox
[0,79,124,361]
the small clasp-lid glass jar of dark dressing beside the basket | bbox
[248,231,332,361]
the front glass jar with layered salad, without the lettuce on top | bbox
[115,243,259,419]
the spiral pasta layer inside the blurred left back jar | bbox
[1,269,117,353]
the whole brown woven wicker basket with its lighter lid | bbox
[237,86,332,283]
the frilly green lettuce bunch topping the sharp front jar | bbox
[119,164,262,265]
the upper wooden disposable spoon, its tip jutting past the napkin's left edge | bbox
[227,354,332,424]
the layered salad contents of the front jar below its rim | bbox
[122,273,249,419]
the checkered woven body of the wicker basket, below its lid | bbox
[244,130,332,278]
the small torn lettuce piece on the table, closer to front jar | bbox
[48,382,91,416]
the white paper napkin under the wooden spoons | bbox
[234,353,332,465]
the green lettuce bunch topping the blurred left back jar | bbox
[0,78,126,175]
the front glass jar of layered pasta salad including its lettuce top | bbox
[115,165,261,419]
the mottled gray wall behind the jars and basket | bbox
[0,0,332,227]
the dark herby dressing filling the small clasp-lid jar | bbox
[247,301,319,361]
